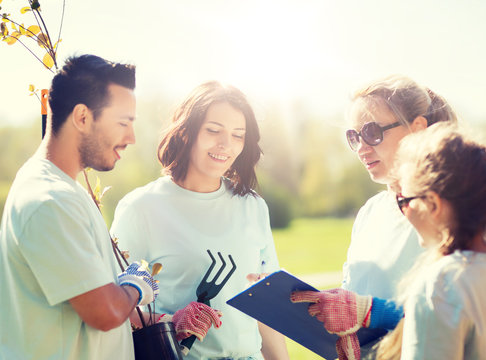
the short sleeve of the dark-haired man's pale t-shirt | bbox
[19,198,114,305]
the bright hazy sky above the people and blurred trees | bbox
[0,0,486,126]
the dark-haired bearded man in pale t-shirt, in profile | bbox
[0,55,158,360]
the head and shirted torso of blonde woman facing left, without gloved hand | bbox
[342,75,456,299]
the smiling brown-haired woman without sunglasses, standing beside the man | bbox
[111,82,288,360]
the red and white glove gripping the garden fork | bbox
[157,301,223,341]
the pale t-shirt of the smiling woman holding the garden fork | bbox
[111,177,278,359]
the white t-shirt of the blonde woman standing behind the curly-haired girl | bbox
[342,191,423,299]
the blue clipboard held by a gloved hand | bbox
[226,270,386,360]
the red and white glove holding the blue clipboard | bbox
[290,288,372,360]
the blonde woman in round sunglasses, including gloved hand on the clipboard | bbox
[292,75,457,359]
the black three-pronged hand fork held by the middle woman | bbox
[181,250,236,355]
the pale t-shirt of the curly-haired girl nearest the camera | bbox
[402,251,486,360]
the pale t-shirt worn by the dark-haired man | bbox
[0,157,134,360]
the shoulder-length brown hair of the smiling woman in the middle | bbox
[157,81,262,196]
